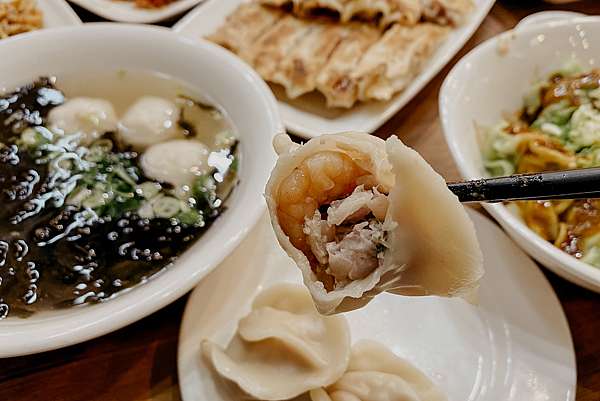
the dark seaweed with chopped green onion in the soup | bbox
[0,78,238,319]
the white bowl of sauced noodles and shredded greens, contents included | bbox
[440,17,600,292]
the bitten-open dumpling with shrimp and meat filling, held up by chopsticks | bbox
[266,133,483,314]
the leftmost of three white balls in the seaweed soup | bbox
[48,97,117,145]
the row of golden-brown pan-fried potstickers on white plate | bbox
[208,0,473,108]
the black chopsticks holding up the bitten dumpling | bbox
[448,167,600,203]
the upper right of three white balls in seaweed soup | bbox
[119,96,180,149]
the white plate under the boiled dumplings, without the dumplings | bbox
[178,211,576,401]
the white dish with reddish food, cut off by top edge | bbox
[68,0,202,24]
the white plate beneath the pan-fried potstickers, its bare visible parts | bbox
[173,0,494,138]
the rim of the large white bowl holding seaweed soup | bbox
[0,22,285,358]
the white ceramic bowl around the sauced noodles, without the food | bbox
[439,17,600,292]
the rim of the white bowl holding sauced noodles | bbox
[438,16,600,292]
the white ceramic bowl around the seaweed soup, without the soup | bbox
[0,23,283,357]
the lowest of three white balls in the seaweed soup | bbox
[140,139,210,186]
